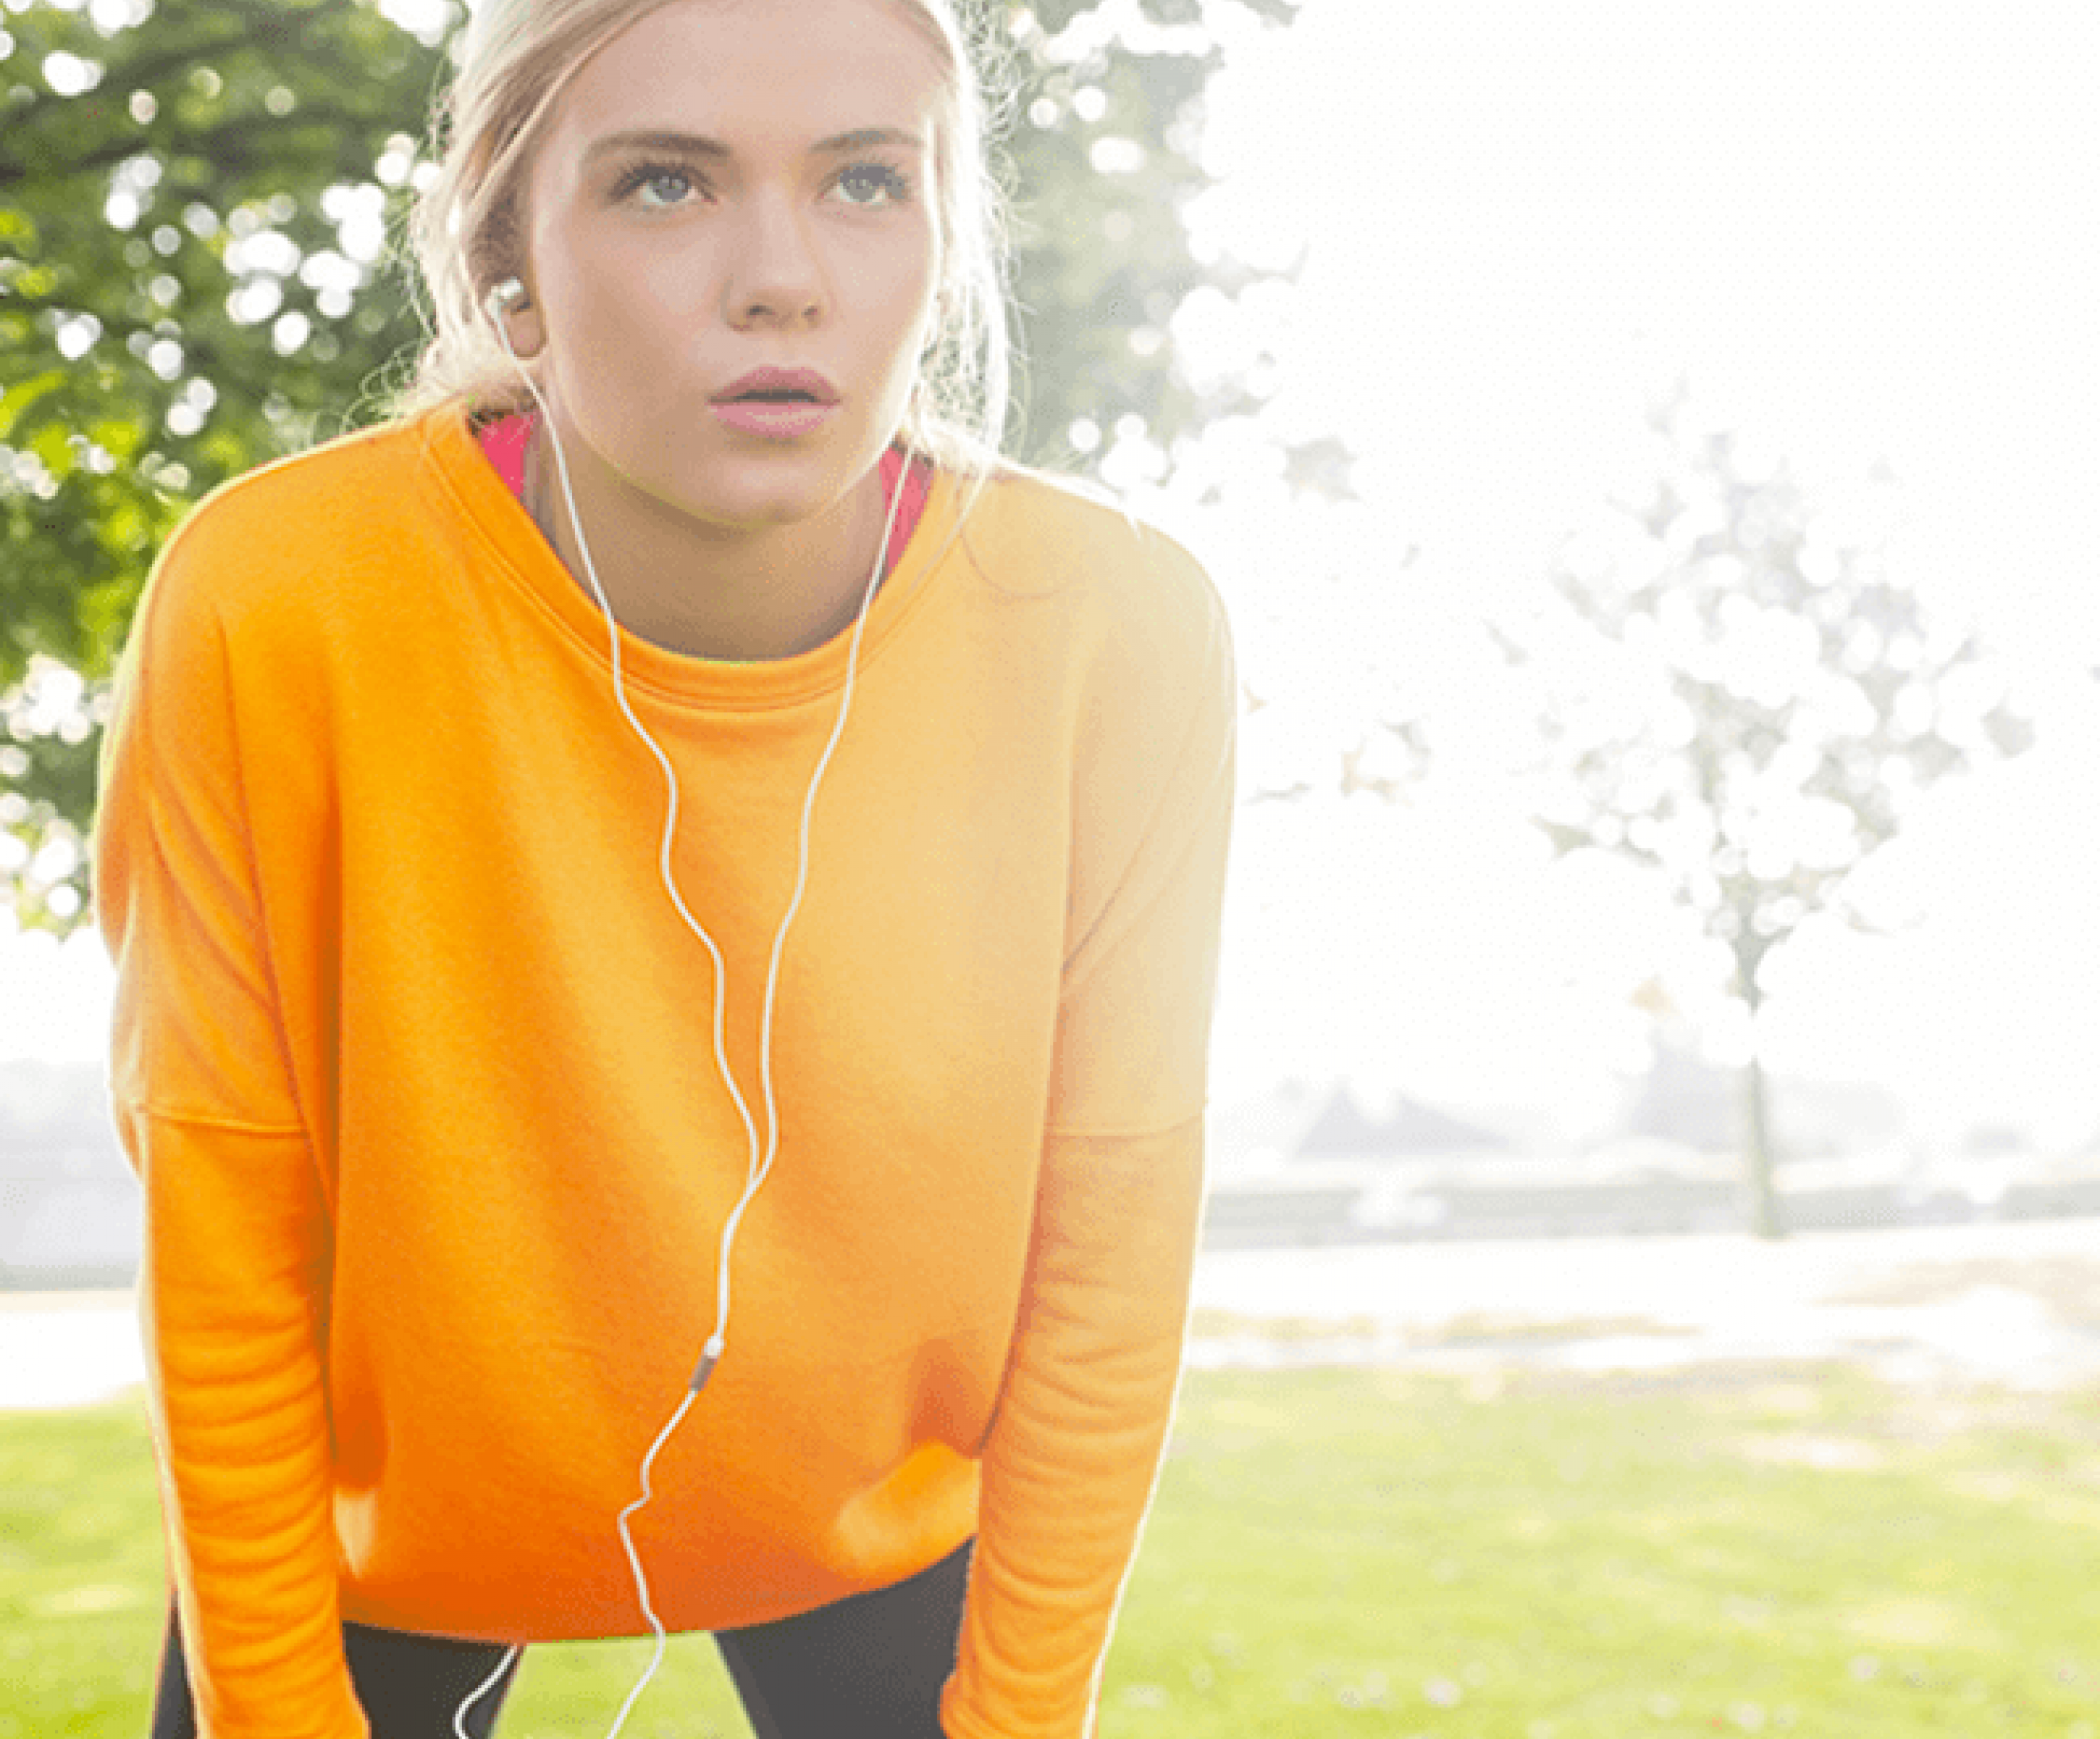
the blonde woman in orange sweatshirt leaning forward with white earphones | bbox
[96,0,1233,1739]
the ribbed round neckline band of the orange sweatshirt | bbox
[429,403,958,710]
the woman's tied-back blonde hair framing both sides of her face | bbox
[399,0,1012,475]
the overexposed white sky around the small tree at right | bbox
[0,0,2100,1144]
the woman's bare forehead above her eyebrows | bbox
[554,0,945,153]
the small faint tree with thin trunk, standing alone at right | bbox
[1497,391,2033,1237]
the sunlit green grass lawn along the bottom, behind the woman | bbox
[0,1367,2100,1739]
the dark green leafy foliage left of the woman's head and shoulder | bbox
[0,0,441,930]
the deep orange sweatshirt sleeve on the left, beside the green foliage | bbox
[94,534,365,1739]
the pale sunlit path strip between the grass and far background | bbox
[0,1220,2100,1407]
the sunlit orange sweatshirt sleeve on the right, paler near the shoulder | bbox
[941,550,1237,1739]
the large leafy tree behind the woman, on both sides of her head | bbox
[0,0,1346,930]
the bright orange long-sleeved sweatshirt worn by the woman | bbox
[96,409,1235,1739]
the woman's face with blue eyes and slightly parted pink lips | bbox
[512,0,941,529]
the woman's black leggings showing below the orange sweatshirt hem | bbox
[151,1542,970,1739]
